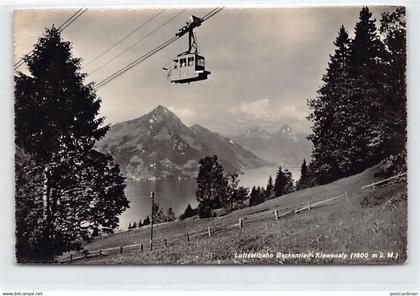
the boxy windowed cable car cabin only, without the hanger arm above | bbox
[168,53,210,83]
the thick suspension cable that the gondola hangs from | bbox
[94,7,223,89]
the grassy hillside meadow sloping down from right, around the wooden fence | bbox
[77,169,407,264]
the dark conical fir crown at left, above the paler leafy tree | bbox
[15,27,109,161]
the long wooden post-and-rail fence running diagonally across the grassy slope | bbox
[55,192,348,263]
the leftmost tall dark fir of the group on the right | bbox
[308,26,350,184]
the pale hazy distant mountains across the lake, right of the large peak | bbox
[233,124,311,166]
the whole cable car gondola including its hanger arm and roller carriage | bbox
[163,15,210,83]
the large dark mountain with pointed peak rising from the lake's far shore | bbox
[97,106,266,180]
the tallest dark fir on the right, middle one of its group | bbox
[346,7,385,169]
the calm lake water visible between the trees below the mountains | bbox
[120,167,300,230]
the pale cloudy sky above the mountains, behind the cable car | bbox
[14,6,393,135]
